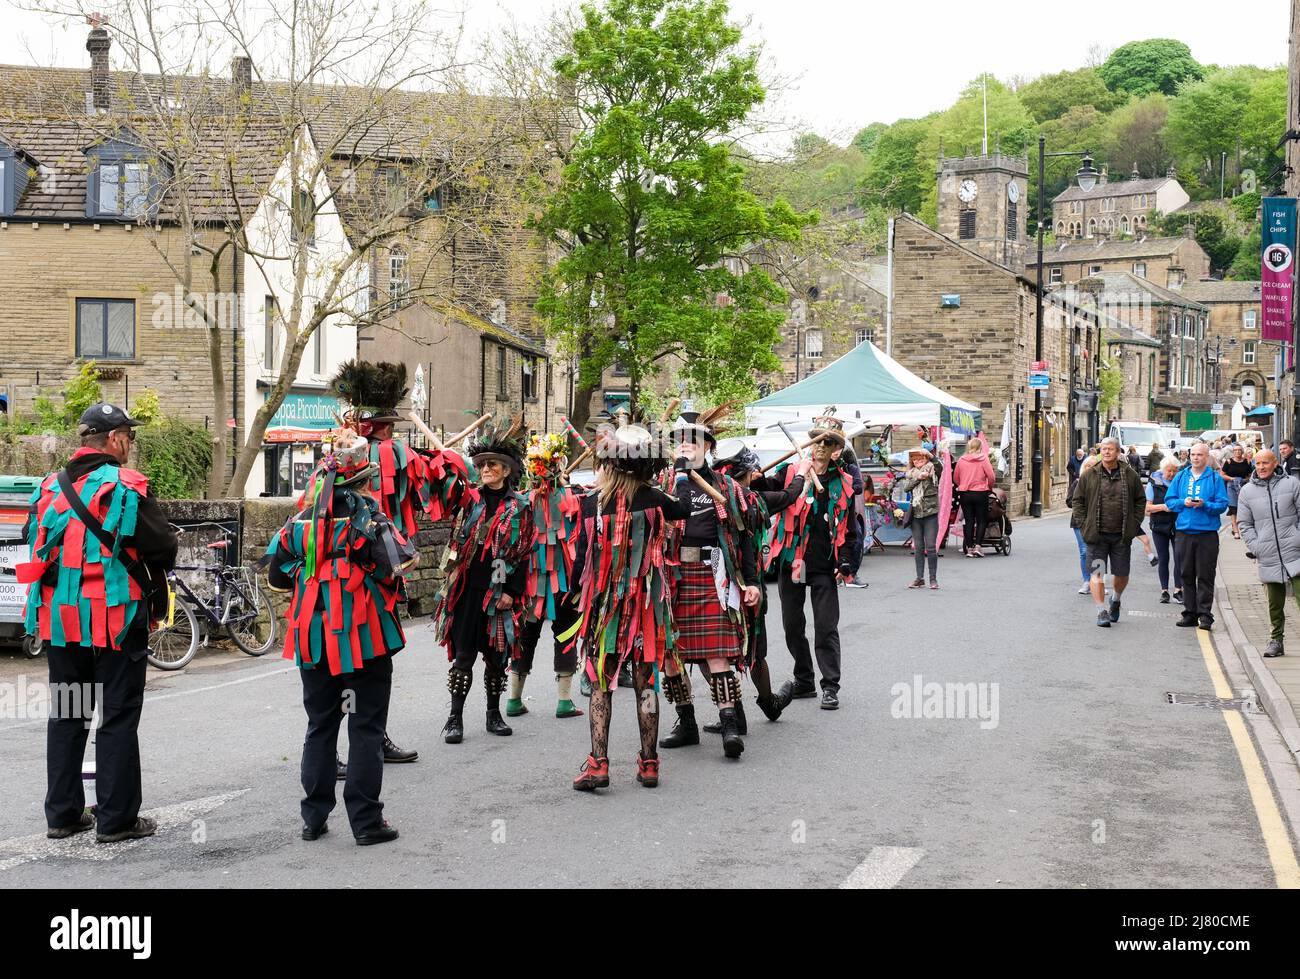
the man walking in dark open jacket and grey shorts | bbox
[1074,438,1147,627]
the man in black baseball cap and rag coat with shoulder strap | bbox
[18,403,177,842]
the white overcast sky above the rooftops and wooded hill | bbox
[0,0,1288,142]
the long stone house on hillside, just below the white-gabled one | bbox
[1028,230,1210,290]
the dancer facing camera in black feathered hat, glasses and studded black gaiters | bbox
[433,420,533,745]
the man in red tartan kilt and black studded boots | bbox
[659,406,759,758]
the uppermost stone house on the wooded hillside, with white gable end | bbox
[1052,166,1191,241]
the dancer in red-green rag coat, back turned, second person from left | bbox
[264,429,417,845]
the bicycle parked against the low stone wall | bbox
[148,523,276,671]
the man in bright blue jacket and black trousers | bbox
[1165,442,1227,629]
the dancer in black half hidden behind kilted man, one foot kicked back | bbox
[705,438,813,736]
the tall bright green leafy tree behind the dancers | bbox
[537,0,813,424]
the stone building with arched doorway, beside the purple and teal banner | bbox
[1182,280,1282,410]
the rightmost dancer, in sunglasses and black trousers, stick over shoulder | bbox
[767,410,858,710]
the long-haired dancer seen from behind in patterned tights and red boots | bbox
[573,424,690,792]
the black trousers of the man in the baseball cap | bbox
[46,642,148,833]
